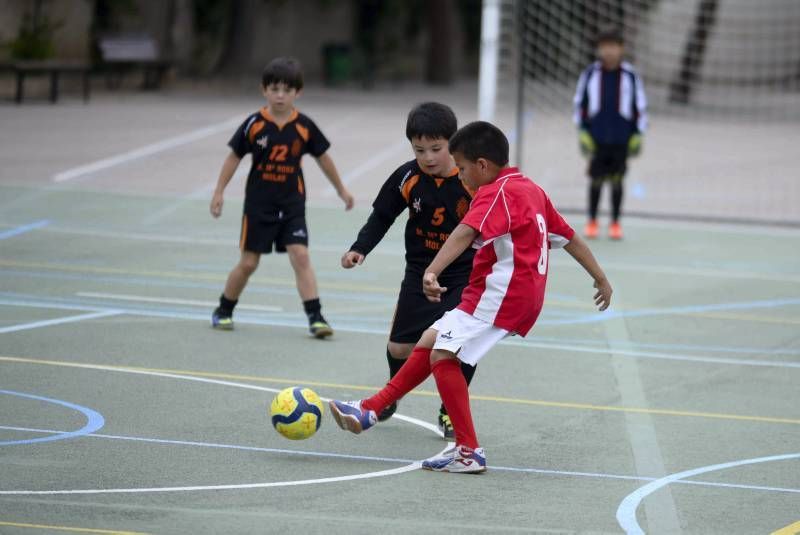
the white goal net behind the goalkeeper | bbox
[498,0,800,224]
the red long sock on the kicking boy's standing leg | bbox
[431,359,478,449]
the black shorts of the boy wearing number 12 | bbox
[239,214,308,254]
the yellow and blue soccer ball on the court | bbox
[269,386,323,440]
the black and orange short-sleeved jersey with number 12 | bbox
[228,108,330,219]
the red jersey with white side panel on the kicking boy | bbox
[458,167,575,336]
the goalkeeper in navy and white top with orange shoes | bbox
[574,30,647,240]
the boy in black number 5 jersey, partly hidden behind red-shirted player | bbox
[342,102,475,439]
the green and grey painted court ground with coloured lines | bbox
[0,92,800,535]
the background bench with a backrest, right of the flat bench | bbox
[97,35,172,89]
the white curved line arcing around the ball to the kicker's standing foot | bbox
[0,357,453,496]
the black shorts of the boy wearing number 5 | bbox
[389,272,468,344]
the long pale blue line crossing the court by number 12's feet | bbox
[0,292,800,369]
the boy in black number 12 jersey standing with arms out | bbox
[210,58,353,338]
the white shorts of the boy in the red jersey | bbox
[431,308,509,366]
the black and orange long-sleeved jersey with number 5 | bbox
[350,160,475,281]
